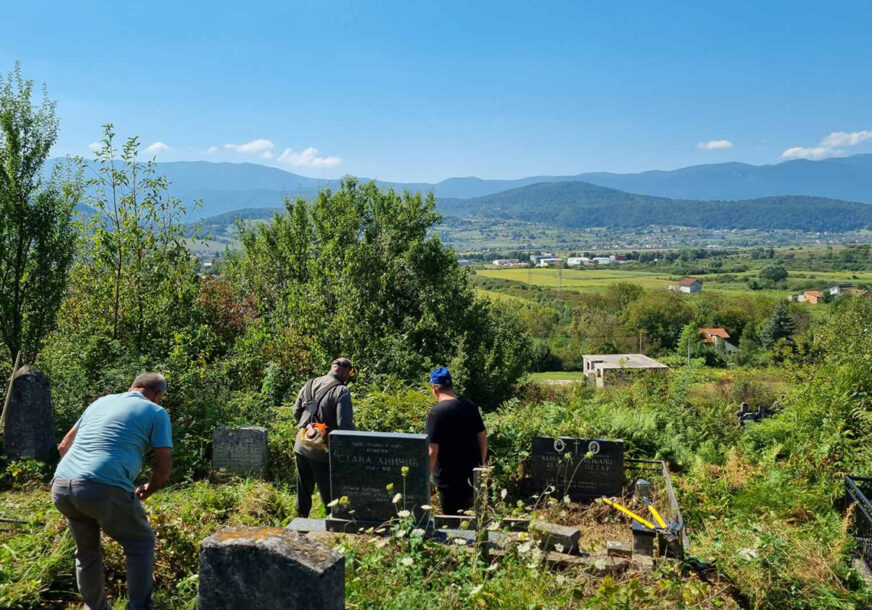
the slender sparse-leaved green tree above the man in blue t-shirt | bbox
[64,125,198,354]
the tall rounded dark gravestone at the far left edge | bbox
[3,366,57,462]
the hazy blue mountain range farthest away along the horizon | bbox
[46,155,872,218]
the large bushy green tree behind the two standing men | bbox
[228,178,530,405]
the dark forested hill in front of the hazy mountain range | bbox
[438,182,872,231]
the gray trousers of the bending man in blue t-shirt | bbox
[51,479,154,610]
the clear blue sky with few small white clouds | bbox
[0,0,872,181]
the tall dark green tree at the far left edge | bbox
[0,64,82,362]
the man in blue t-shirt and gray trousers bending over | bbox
[51,373,173,610]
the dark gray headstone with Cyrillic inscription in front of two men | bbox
[330,430,430,522]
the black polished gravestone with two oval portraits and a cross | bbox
[532,436,624,502]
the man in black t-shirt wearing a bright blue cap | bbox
[426,367,487,515]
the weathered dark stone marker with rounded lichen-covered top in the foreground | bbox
[198,527,345,610]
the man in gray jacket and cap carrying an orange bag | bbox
[294,358,354,517]
